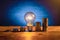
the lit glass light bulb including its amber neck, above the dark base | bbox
[24,12,36,26]
